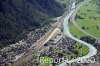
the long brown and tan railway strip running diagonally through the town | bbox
[13,9,66,66]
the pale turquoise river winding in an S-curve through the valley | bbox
[58,0,97,66]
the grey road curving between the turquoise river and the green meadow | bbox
[72,2,100,40]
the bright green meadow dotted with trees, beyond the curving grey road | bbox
[75,2,100,38]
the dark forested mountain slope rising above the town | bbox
[0,0,66,47]
